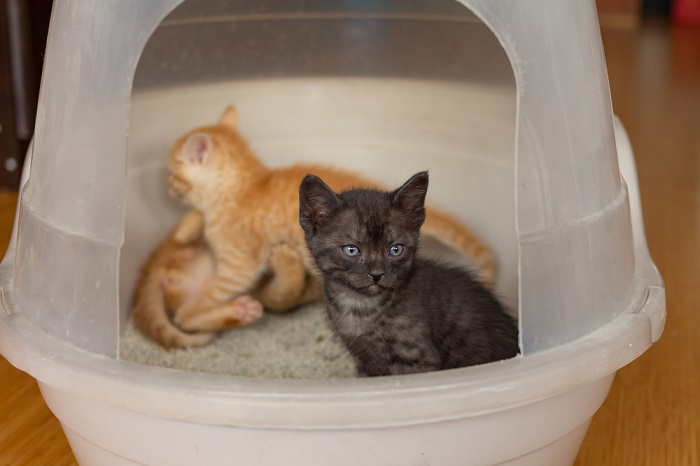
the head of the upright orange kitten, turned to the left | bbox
[168,106,261,208]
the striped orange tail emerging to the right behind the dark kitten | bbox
[422,207,496,287]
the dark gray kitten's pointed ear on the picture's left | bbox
[299,175,343,238]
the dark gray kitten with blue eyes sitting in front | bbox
[299,172,519,376]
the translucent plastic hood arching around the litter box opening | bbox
[6,0,658,357]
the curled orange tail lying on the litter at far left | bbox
[134,252,215,349]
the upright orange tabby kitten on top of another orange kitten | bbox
[152,107,493,344]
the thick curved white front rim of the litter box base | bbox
[0,272,663,429]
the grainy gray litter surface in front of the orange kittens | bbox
[120,305,356,380]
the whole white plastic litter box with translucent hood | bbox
[0,0,665,466]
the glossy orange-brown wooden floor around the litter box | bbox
[0,18,700,466]
